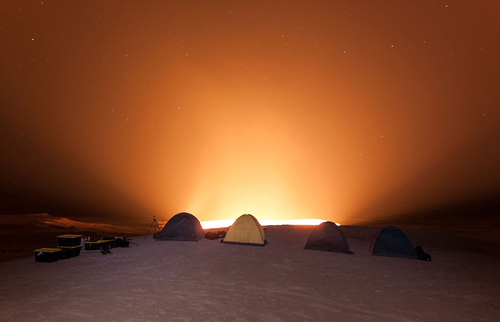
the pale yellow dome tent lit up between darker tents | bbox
[223,215,266,246]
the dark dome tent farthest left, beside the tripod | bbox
[157,212,205,241]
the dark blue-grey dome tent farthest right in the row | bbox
[370,226,417,259]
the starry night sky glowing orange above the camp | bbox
[0,0,500,223]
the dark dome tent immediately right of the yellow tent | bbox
[304,221,352,254]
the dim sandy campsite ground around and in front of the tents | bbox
[0,226,500,321]
